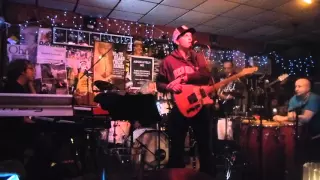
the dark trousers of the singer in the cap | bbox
[168,107,215,174]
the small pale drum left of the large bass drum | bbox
[101,120,131,144]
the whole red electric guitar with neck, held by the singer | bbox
[173,67,258,118]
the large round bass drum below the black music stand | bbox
[128,128,169,170]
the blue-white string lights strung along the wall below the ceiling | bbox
[11,12,315,76]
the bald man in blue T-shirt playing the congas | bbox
[273,78,320,161]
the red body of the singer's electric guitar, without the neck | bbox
[173,85,213,118]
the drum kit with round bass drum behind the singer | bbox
[94,82,199,179]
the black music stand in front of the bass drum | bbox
[94,93,161,169]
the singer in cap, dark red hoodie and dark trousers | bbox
[156,25,215,176]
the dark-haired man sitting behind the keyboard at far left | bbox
[0,59,35,162]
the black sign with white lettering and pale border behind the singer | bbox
[130,56,154,89]
